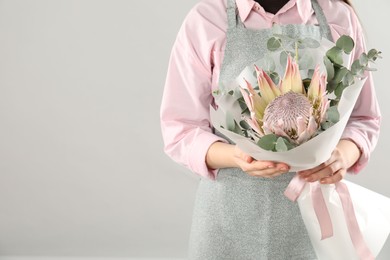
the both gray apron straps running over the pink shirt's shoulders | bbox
[227,0,333,41]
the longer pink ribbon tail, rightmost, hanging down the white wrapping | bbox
[336,182,375,260]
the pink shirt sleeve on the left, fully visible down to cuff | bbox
[160,3,226,179]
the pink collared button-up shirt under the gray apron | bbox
[161,0,380,179]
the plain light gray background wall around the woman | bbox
[0,0,390,259]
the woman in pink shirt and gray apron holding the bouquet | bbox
[161,0,380,260]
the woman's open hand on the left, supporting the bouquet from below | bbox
[234,146,290,178]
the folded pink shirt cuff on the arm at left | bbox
[188,132,227,180]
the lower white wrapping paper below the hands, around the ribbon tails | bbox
[298,180,390,260]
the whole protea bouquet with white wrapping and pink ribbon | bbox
[211,35,390,260]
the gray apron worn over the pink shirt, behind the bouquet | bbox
[189,0,331,260]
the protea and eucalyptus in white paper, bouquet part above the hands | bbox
[211,35,381,171]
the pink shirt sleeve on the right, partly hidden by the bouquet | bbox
[341,6,381,173]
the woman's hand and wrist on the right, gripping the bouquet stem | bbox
[298,140,360,184]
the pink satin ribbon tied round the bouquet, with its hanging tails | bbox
[284,174,375,260]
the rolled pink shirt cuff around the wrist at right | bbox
[341,129,370,174]
